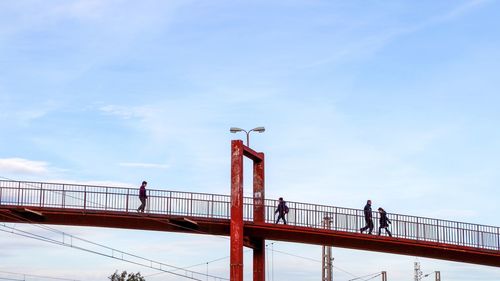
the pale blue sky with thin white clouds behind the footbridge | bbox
[0,0,500,281]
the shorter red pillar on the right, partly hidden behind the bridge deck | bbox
[253,153,266,281]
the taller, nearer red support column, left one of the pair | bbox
[230,140,243,281]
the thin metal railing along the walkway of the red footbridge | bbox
[0,180,500,251]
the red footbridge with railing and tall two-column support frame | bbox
[0,141,500,281]
